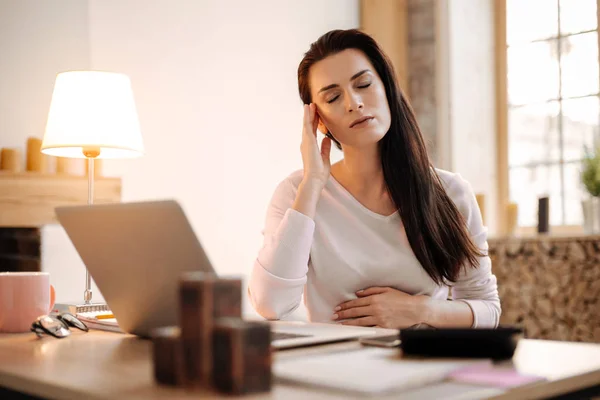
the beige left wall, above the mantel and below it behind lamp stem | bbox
[0,0,102,301]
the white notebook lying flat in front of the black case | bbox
[273,348,491,395]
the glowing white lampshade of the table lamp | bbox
[42,71,144,158]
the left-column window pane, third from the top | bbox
[508,101,560,167]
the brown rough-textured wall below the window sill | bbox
[489,236,600,343]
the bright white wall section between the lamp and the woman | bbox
[89,0,358,318]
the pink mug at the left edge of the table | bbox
[0,272,55,333]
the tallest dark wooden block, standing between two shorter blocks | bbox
[179,272,242,387]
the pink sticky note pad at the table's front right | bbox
[449,367,544,388]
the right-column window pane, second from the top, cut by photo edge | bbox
[560,32,600,98]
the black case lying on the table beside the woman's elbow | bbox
[400,327,523,360]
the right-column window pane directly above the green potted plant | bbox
[562,96,600,161]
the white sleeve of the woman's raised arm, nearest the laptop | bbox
[248,179,315,319]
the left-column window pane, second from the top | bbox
[508,40,559,104]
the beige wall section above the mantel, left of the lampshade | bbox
[0,0,90,150]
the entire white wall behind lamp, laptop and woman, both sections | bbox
[0,0,358,311]
